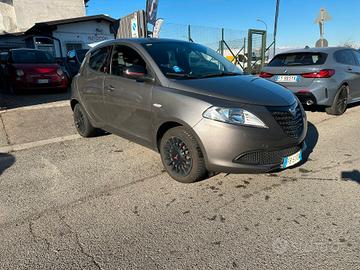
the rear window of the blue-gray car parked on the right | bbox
[268,53,327,67]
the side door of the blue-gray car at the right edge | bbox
[334,49,359,99]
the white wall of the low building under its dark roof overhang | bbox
[53,21,114,57]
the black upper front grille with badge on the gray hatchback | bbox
[269,103,304,138]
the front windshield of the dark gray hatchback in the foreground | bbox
[143,41,242,79]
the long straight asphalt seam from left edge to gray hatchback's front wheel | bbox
[0,172,164,229]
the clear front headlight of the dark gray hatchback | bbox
[203,107,268,128]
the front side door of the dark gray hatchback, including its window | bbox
[104,45,153,143]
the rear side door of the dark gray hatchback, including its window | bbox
[78,46,112,123]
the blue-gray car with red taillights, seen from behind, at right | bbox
[260,47,360,115]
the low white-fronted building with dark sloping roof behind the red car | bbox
[0,15,118,58]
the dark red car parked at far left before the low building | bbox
[4,48,69,94]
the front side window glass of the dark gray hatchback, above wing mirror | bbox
[111,45,146,76]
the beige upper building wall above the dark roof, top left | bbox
[0,0,88,33]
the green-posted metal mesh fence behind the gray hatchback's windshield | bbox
[161,23,272,73]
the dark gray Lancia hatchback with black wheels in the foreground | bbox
[71,39,307,183]
